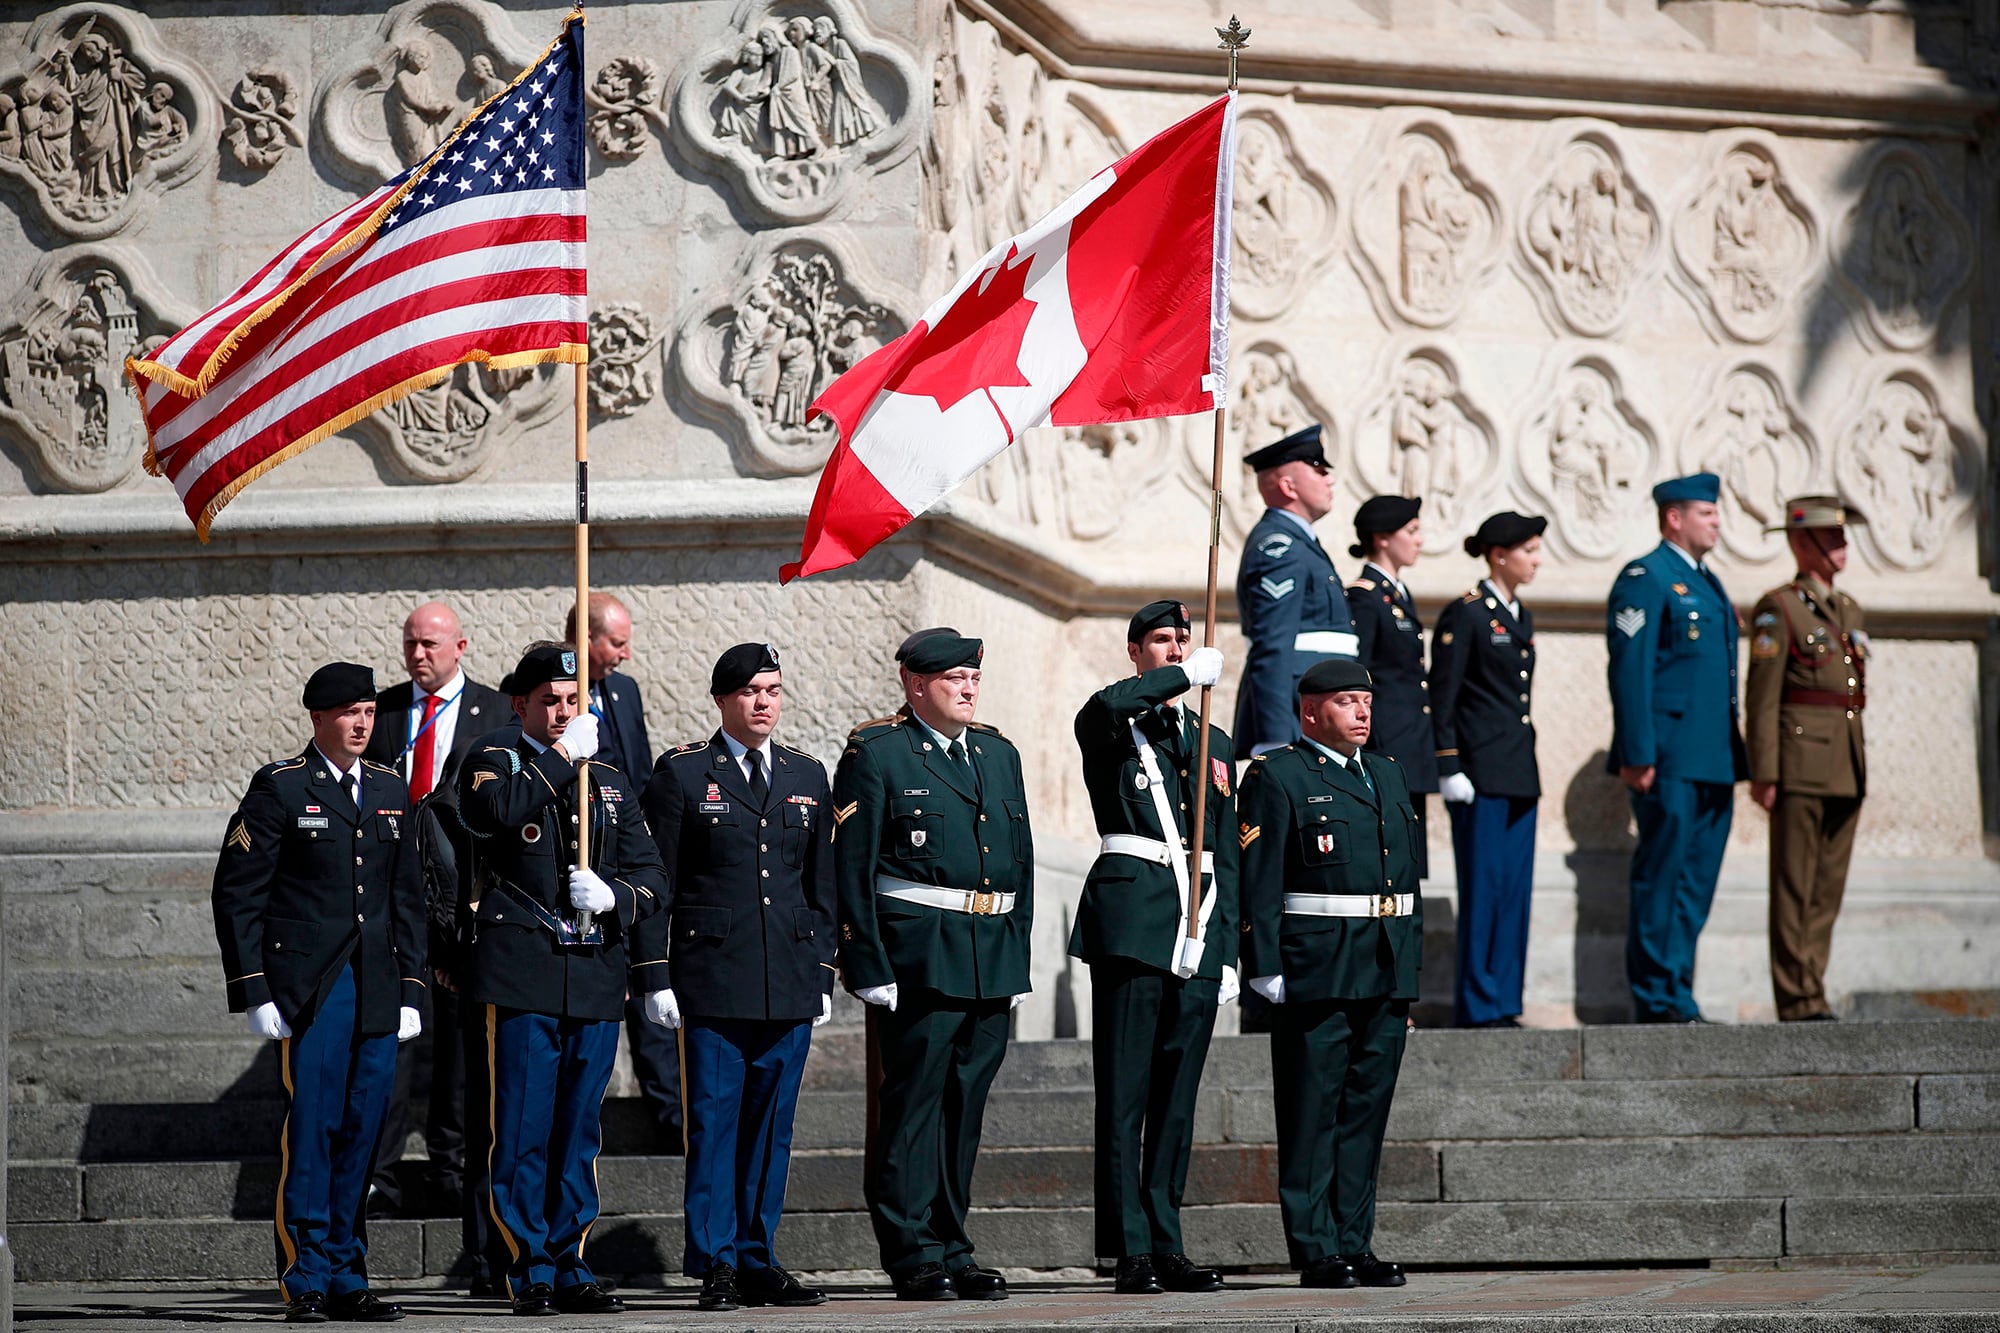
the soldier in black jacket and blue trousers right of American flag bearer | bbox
[646,642,834,1311]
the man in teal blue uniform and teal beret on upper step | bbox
[1604,472,1750,1023]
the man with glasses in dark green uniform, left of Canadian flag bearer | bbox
[834,630,1034,1301]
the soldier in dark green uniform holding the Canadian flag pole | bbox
[1070,602,1238,1295]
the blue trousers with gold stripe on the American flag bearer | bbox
[486,1005,618,1297]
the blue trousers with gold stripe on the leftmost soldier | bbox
[276,967,396,1301]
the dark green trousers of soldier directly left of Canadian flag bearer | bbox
[866,987,1010,1281]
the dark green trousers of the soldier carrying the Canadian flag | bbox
[1090,959,1220,1259]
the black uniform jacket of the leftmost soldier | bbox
[210,745,426,1033]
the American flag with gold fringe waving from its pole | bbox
[126,12,588,540]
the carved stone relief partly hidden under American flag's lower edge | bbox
[354,362,570,482]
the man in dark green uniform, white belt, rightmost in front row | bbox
[1238,658,1424,1287]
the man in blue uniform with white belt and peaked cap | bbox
[1236,426,1360,759]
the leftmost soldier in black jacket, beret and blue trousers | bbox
[212,662,424,1323]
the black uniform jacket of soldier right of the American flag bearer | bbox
[644,731,834,1023]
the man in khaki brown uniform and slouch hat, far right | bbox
[1744,494,1868,1023]
